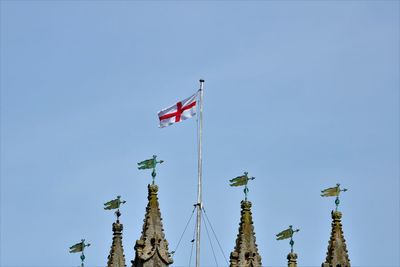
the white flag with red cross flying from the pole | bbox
[158,92,198,128]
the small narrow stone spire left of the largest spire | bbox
[107,218,126,267]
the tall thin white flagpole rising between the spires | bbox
[196,79,204,267]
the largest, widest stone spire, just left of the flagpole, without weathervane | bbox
[132,184,173,267]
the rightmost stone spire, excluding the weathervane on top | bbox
[321,211,350,267]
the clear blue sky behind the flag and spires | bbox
[0,1,400,267]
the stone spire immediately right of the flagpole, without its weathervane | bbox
[230,200,262,267]
